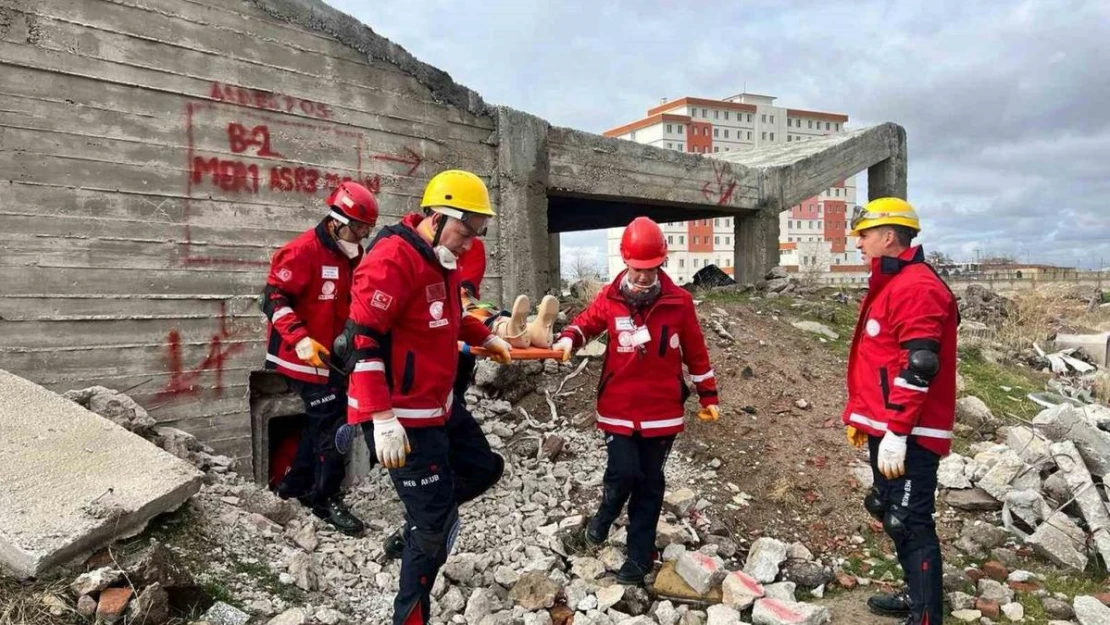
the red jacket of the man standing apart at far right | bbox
[842,246,959,455]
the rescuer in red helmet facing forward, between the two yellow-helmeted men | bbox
[553,216,719,584]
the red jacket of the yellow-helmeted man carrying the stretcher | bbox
[347,214,490,427]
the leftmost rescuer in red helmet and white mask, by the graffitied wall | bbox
[262,182,377,535]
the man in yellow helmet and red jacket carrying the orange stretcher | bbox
[336,170,511,625]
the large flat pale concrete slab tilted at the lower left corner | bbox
[0,370,202,578]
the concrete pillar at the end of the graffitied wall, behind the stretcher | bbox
[491,107,558,305]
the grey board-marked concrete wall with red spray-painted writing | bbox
[0,0,501,457]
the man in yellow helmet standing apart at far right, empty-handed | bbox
[842,198,959,625]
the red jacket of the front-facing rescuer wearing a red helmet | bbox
[559,271,717,436]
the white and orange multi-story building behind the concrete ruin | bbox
[604,93,867,283]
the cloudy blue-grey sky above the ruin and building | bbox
[329,0,1110,268]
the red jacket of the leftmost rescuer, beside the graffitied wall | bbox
[262,221,359,384]
